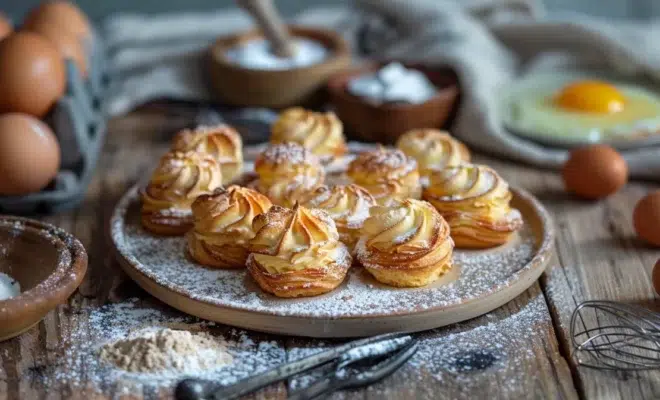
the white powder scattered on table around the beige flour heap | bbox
[50,299,285,393]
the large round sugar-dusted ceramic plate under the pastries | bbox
[110,187,553,337]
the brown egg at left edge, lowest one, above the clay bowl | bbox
[0,113,60,195]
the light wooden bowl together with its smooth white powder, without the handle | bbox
[208,26,351,108]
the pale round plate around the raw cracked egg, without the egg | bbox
[499,70,660,150]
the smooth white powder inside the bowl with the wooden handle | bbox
[225,38,329,70]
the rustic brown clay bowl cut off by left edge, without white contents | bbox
[0,216,87,341]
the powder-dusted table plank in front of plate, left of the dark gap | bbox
[289,284,578,400]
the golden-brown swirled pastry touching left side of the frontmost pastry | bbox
[187,185,272,268]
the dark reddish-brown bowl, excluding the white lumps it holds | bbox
[328,63,459,143]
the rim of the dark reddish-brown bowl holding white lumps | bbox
[327,60,458,112]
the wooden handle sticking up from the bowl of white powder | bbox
[237,0,295,58]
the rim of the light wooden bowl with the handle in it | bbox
[209,25,351,75]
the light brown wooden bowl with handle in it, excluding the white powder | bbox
[209,26,351,108]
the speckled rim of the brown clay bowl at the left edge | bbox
[0,215,87,328]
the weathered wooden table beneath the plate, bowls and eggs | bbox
[0,109,660,399]
